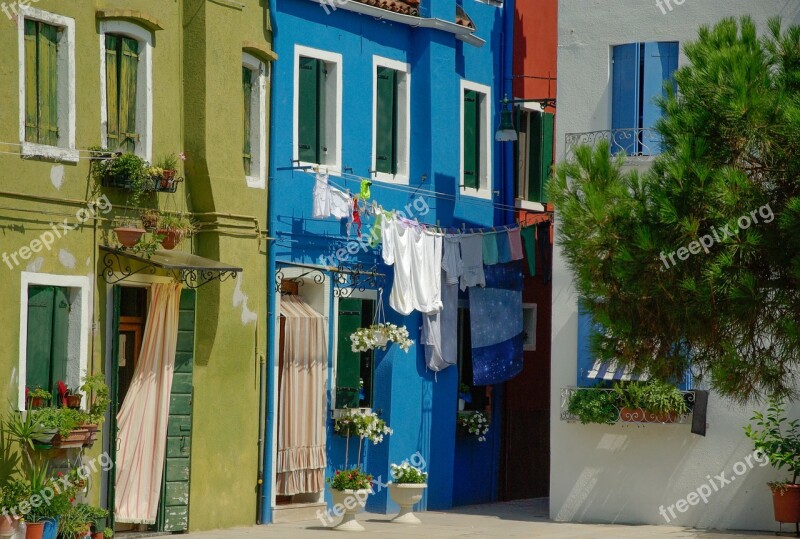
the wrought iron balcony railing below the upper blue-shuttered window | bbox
[564,129,661,163]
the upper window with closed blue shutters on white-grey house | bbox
[611,41,679,155]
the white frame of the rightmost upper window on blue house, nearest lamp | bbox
[458,79,494,200]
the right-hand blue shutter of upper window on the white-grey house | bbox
[641,41,678,155]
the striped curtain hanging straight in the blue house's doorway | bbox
[276,296,328,496]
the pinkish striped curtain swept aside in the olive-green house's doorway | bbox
[114,283,181,524]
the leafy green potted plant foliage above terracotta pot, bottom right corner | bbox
[744,399,800,488]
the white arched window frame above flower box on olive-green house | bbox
[100,21,153,162]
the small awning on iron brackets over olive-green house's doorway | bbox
[100,245,242,288]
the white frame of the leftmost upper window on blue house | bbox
[292,45,342,173]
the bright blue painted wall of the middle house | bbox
[263,0,513,522]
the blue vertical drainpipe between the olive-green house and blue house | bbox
[258,0,278,524]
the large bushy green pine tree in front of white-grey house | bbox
[549,18,800,402]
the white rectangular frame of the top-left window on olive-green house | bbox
[17,3,78,163]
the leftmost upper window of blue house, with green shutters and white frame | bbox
[294,46,342,169]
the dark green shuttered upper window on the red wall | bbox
[517,110,555,202]
